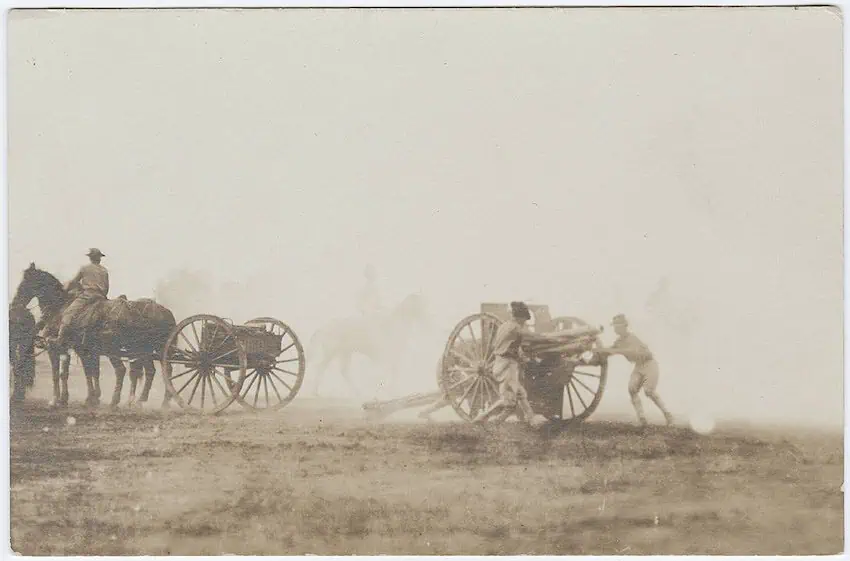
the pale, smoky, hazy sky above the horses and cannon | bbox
[8,8,843,421]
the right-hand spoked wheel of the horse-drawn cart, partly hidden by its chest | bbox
[236,317,306,411]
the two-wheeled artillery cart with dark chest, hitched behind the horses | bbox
[162,314,306,414]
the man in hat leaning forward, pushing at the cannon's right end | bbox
[595,314,673,425]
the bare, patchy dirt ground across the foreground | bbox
[10,360,843,555]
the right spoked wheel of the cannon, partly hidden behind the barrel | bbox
[547,316,608,422]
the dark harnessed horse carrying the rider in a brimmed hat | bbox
[12,263,177,406]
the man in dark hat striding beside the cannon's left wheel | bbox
[473,302,552,424]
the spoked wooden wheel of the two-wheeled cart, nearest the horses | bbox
[162,314,247,414]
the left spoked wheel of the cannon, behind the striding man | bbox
[437,313,502,421]
